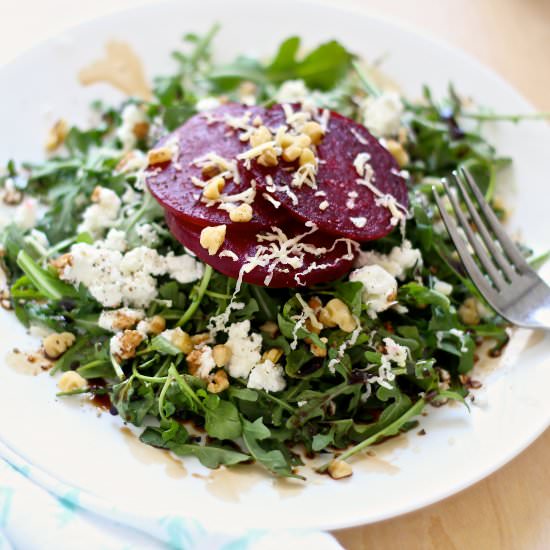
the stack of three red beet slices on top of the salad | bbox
[146,103,408,287]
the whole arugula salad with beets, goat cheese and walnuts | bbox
[0,27,530,479]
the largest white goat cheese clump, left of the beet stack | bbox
[60,241,202,308]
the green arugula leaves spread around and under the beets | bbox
[0,27,538,484]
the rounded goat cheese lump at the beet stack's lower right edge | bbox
[349,264,397,319]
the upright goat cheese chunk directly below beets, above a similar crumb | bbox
[225,320,262,378]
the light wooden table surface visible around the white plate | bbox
[0,0,550,550]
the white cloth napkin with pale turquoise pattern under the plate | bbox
[0,443,342,550]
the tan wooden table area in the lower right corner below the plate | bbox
[335,431,550,550]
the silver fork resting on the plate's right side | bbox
[433,169,550,330]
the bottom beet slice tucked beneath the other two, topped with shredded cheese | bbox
[166,212,358,288]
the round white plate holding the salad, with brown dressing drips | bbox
[0,0,550,529]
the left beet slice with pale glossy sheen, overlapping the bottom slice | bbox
[146,103,285,232]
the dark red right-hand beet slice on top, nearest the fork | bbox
[243,105,408,241]
